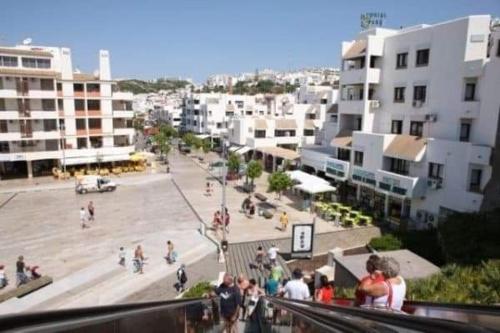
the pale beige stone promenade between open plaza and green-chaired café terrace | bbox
[169,153,343,243]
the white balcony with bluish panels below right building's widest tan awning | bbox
[376,169,427,199]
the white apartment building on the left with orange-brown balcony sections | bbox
[0,45,134,178]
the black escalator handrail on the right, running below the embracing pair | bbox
[266,296,498,333]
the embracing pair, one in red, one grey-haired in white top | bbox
[355,254,406,311]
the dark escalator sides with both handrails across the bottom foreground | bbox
[0,297,500,333]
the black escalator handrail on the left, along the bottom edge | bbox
[0,298,207,330]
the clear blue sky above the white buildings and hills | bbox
[0,0,500,82]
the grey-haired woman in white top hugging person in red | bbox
[362,257,406,311]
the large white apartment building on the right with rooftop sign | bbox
[302,15,500,228]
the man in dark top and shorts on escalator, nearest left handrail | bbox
[215,273,241,333]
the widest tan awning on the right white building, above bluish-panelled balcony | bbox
[384,135,427,162]
